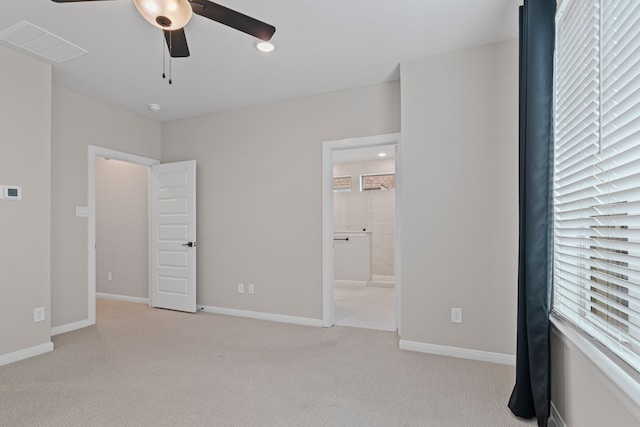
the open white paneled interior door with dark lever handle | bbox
[150,160,196,313]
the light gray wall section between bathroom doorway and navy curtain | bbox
[400,41,518,355]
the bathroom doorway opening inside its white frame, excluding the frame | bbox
[333,144,396,331]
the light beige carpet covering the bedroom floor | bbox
[0,300,530,427]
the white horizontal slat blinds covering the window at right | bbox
[553,0,640,371]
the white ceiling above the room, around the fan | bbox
[0,0,519,121]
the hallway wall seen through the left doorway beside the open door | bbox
[95,158,149,298]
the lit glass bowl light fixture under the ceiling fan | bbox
[133,0,193,31]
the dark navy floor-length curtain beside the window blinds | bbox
[509,0,556,427]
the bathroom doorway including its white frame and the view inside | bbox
[323,134,400,330]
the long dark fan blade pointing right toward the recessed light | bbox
[189,0,276,41]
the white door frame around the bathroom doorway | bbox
[322,133,402,333]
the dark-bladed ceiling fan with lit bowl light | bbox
[52,0,276,58]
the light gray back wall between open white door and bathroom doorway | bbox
[162,81,400,319]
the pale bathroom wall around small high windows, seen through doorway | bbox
[333,160,396,276]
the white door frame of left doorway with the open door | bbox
[87,145,160,325]
